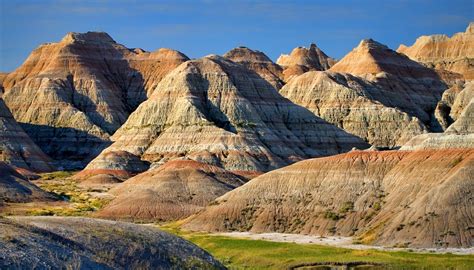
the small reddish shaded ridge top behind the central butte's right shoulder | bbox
[224,47,284,90]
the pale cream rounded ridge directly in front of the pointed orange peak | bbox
[280,71,426,148]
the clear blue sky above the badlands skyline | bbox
[0,0,474,71]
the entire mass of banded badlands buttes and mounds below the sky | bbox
[0,25,474,258]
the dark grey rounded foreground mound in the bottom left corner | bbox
[0,217,225,269]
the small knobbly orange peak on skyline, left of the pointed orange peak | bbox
[277,43,336,82]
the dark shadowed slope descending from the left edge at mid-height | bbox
[0,95,54,172]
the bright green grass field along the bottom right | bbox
[160,224,474,269]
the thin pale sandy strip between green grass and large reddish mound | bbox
[213,232,474,255]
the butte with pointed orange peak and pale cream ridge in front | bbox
[280,40,447,148]
